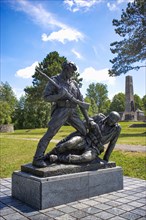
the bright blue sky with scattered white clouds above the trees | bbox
[1,0,146,99]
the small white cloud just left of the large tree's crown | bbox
[16,61,38,79]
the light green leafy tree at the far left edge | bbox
[0,82,17,124]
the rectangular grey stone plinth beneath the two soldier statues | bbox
[12,167,123,209]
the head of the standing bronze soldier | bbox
[62,61,77,78]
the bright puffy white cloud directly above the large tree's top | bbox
[42,28,84,44]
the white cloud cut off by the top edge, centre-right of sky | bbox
[64,0,103,12]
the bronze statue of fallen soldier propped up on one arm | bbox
[45,111,121,164]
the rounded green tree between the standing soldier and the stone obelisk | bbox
[86,83,108,113]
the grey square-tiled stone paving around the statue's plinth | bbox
[0,177,146,220]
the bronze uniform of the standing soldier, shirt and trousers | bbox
[34,75,86,159]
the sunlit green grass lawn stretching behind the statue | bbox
[0,122,146,179]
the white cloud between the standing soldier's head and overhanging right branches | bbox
[81,67,116,85]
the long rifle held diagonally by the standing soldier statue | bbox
[36,67,90,109]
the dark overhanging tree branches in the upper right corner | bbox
[109,0,146,76]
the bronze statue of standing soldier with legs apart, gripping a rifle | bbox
[32,61,90,167]
